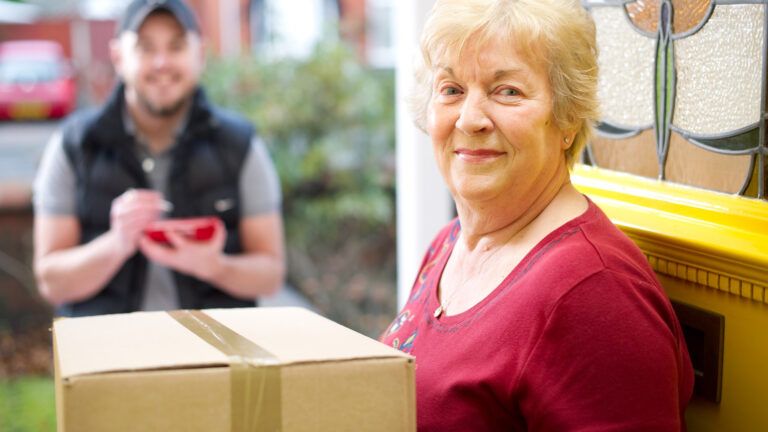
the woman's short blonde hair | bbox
[409,0,598,166]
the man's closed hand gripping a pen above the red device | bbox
[110,189,168,258]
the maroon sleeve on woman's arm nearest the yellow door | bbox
[518,270,692,432]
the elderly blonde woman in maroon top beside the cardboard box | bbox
[382,0,693,431]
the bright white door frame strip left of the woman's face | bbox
[394,0,453,308]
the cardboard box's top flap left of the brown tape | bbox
[53,312,228,378]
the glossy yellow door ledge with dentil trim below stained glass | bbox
[572,165,768,298]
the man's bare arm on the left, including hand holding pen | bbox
[34,190,168,305]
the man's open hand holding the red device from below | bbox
[139,219,227,281]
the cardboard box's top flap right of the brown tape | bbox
[204,307,410,363]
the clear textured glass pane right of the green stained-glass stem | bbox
[672,4,764,134]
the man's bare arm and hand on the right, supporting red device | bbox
[140,212,285,299]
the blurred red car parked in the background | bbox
[0,40,77,120]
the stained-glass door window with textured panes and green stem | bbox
[584,0,768,199]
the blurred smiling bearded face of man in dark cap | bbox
[112,12,204,116]
